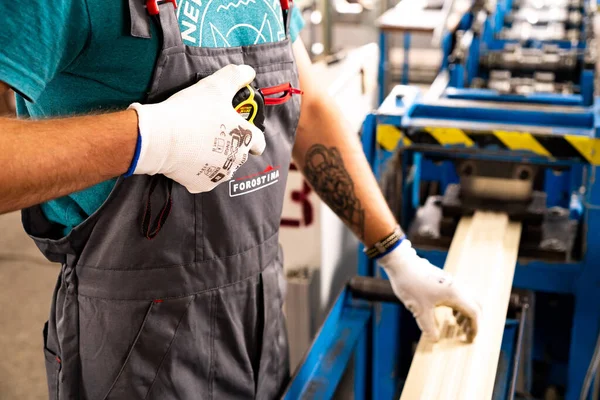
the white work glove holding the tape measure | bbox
[129,65,266,193]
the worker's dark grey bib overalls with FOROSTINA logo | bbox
[23,0,300,400]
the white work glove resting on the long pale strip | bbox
[378,239,481,342]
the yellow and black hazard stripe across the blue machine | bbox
[377,125,600,165]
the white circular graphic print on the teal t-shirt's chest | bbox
[177,0,285,47]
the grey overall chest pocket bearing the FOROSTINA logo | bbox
[196,63,300,260]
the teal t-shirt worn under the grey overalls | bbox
[0,0,303,234]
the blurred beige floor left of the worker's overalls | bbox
[0,213,59,400]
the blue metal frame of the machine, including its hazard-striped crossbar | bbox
[285,0,600,400]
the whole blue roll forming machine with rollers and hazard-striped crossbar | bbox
[286,0,600,400]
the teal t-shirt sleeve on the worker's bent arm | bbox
[0,0,90,101]
